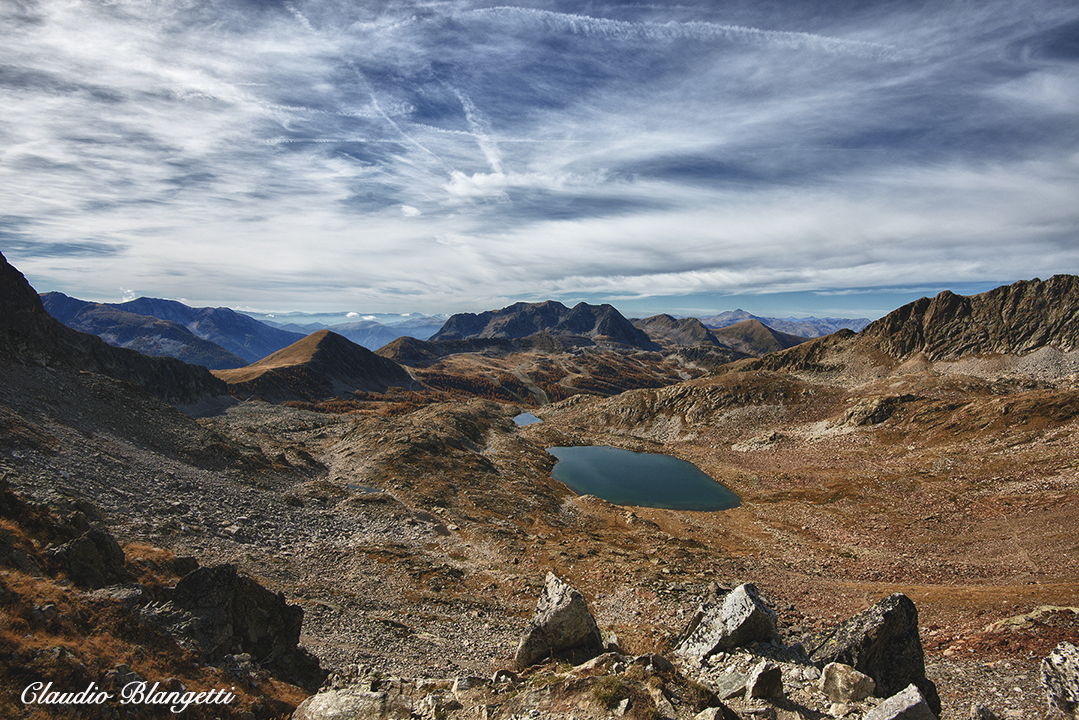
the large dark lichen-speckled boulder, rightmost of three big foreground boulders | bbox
[803,593,941,712]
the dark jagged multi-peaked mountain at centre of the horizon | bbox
[431,300,660,350]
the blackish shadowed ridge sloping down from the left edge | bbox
[0,255,227,405]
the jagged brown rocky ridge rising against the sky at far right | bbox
[860,275,1079,361]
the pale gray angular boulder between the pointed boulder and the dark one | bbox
[674,583,779,661]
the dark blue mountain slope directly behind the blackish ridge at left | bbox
[41,293,247,370]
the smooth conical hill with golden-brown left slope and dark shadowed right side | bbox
[214,330,413,402]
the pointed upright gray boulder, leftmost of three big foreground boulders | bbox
[514,572,603,669]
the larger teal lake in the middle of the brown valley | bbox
[547,445,741,511]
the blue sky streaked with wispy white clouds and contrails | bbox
[0,0,1079,317]
